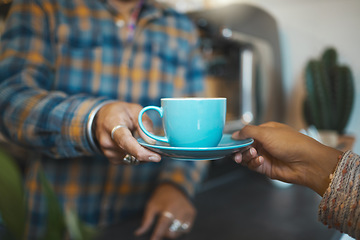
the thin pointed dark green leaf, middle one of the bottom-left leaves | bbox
[39,167,66,240]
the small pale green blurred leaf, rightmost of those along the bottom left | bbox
[65,209,97,240]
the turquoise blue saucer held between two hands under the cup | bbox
[137,134,254,161]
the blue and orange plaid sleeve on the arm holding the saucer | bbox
[0,0,105,158]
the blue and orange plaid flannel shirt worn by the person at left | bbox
[0,0,206,239]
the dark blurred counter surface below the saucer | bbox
[97,163,341,240]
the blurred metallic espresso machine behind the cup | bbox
[188,4,284,132]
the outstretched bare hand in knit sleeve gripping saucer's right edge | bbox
[233,122,342,195]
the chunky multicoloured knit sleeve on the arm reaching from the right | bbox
[319,151,360,239]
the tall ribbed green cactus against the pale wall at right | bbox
[304,48,354,148]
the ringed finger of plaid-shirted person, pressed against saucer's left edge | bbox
[114,128,161,162]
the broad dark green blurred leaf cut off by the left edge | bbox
[0,149,27,240]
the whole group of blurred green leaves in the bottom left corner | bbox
[0,149,98,240]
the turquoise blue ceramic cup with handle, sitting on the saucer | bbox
[138,98,226,148]
